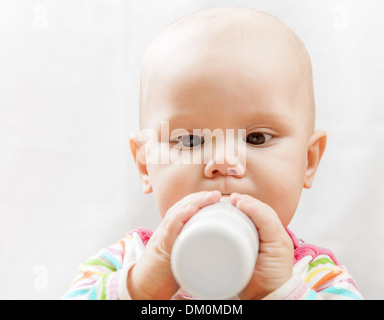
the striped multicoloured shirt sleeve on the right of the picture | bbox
[264,255,363,300]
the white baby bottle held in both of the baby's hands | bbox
[171,197,259,299]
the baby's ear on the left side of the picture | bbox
[129,133,152,193]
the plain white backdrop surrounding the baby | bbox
[0,0,384,299]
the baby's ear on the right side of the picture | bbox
[304,130,327,189]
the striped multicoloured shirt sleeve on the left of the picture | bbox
[62,232,144,300]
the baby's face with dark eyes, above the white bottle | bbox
[134,10,322,226]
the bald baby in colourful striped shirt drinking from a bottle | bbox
[64,8,362,299]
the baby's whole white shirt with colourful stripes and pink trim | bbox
[62,228,363,300]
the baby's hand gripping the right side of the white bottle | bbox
[231,193,293,300]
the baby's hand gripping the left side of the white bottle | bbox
[127,191,221,300]
